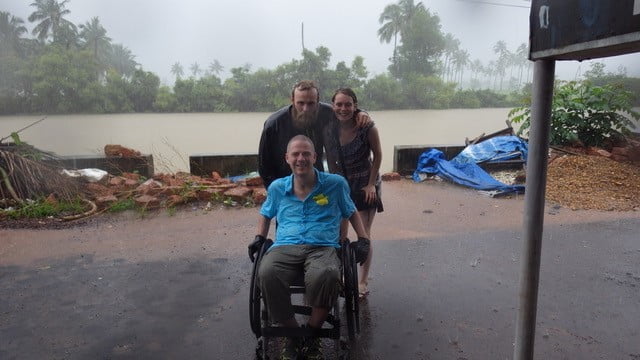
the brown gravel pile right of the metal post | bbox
[546,155,640,211]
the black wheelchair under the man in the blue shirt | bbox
[249,239,360,360]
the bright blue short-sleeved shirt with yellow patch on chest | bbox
[260,169,356,248]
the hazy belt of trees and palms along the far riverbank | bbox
[0,0,640,114]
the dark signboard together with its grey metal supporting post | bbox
[513,0,640,360]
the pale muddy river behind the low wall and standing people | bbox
[0,108,509,172]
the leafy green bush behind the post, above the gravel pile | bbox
[509,80,640,146]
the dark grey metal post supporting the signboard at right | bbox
[513,60,556,360]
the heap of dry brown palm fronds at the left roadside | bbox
[0,150,82,202]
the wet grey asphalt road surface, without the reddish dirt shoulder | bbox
[0,218,640,360]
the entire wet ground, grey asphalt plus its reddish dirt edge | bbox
[0,180,640,359]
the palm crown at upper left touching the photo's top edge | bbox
[29,0,76,42]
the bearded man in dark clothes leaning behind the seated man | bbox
[258,80,371,188]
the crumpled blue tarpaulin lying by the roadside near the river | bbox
[413,137,527,194]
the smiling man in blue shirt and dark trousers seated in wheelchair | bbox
[249,135,369,359]
